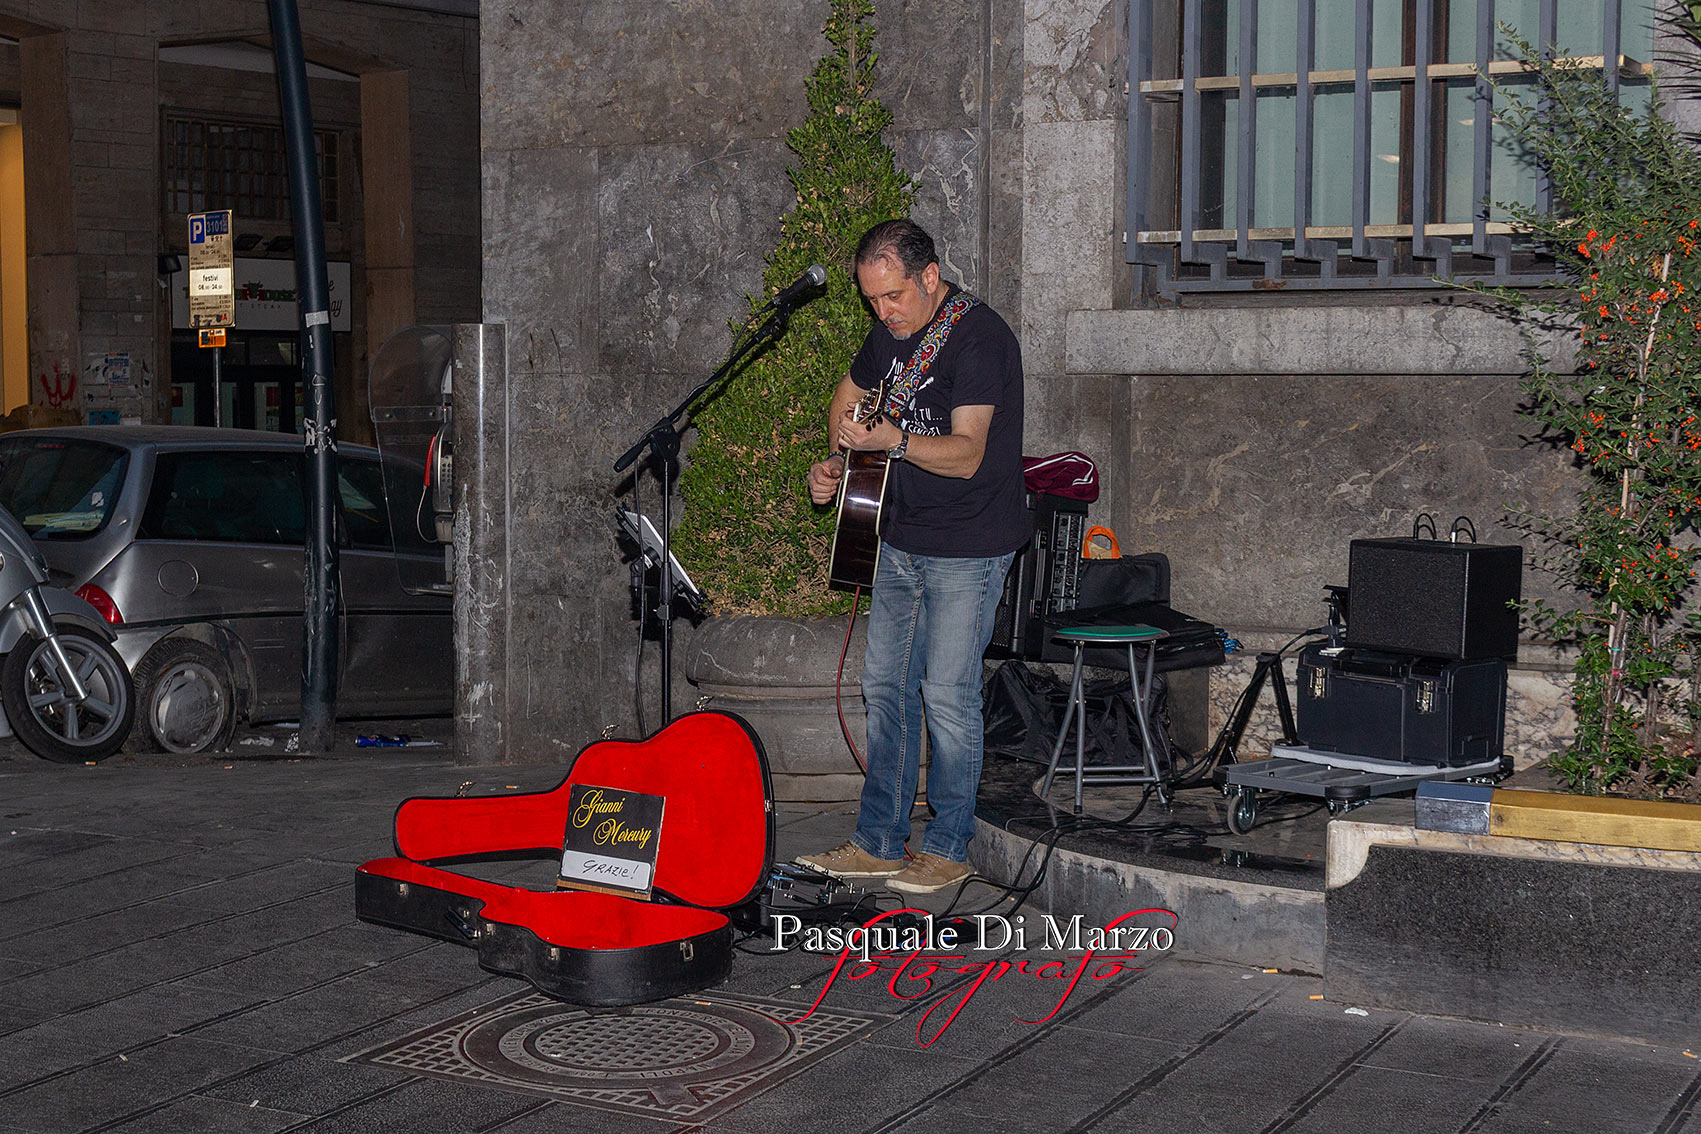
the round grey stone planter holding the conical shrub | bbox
[684,615,925,802]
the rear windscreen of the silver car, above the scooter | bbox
[0,437,129,539]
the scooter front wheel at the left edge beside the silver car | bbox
[0,626,136,763]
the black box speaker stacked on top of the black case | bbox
[1347,539,1524,661]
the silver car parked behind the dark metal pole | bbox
[0,425,454,751]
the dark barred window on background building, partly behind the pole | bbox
[165,114,342,223]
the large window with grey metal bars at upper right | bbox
[1126,0,1653,296]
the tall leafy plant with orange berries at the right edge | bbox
[1497,46,1701,797]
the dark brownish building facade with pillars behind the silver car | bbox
[0,0,480,440]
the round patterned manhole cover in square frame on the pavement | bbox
[349,991,893,1119]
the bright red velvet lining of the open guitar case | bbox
[389,712,769,911]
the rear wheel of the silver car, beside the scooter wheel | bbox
[136,638,236,753]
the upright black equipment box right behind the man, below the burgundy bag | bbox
[987,491,1087,658]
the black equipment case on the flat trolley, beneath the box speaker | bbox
[1294,643,1505,768]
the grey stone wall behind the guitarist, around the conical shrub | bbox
[468,0,1646,763]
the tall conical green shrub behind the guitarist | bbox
[675,0,915,615]
